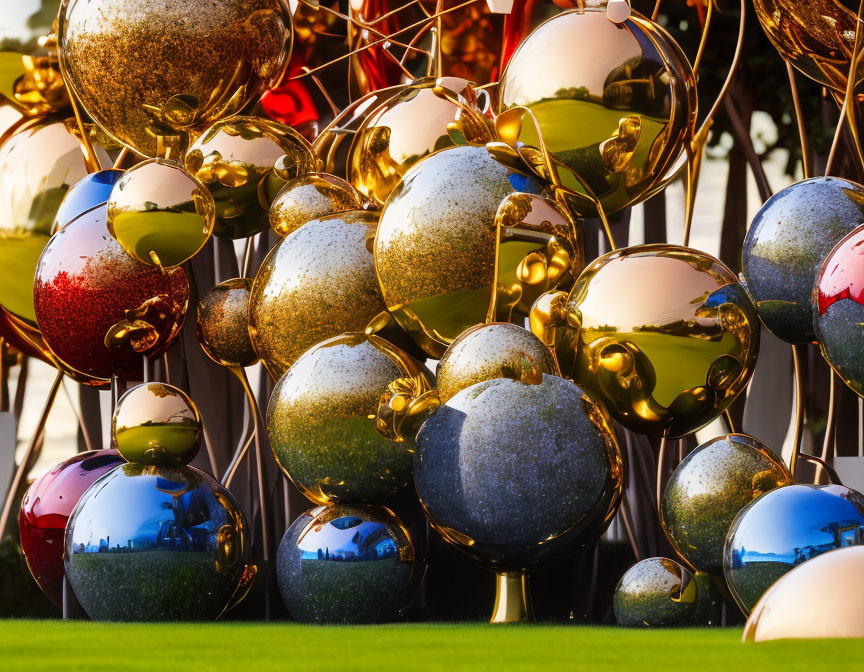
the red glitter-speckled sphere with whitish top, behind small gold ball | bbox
[33,206,189,382]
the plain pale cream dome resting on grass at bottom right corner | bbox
[742,546,864,642]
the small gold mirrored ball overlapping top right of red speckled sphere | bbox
[108,159,216,268]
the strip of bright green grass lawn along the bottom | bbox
[0,621,864,672]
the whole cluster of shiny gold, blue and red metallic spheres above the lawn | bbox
[0,0,864,628]
